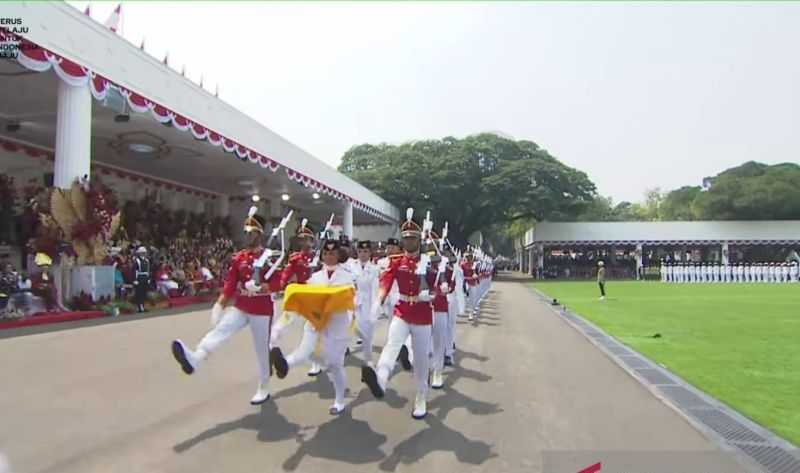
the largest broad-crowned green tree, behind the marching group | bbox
[339,134,595,245]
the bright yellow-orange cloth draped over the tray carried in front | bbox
[283,284,355,331]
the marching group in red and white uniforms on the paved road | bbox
[171,206,494,419]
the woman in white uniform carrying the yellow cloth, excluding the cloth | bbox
[270,240,353,415]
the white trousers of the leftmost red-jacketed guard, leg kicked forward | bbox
[197,307,272,383]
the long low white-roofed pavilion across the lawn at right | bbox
[516,220,800,279]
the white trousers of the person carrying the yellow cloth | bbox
[286,312,350,404]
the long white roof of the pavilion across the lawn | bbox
[532,220,800,246]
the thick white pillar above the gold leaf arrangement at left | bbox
[53,80,92,189]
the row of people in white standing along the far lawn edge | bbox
[661,261,800,283]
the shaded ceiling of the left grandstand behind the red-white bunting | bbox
[0,59,382,224]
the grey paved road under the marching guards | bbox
[0,281,740,473]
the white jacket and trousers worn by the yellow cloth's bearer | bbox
[286,265,353,411]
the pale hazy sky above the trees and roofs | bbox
[72,2,800,201]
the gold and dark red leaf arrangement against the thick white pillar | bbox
[41,180,121,265]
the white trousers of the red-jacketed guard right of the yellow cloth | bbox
[376,317,431,396]
